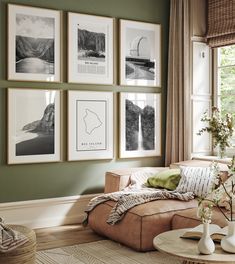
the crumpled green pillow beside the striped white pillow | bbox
[147,169,181,190]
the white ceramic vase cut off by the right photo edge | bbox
[221,221,235,253]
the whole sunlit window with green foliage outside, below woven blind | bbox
[215,45,235,151]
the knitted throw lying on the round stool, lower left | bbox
[0,218,28,253]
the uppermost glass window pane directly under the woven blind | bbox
[218,45,235,67]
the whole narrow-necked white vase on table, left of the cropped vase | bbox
[198,223,215,255]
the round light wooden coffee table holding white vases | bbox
[153,229,235,264]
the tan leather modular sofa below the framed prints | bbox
[88,161,227,251]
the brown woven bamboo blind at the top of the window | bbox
[207,0,235,48]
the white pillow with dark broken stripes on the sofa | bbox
[176,166,214,197]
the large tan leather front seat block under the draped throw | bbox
[88,200,197,251]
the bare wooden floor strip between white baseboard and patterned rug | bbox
[34,225,104,251]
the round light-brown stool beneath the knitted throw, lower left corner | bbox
[0,225,36,264]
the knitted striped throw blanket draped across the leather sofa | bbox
[84,188,194,225]
